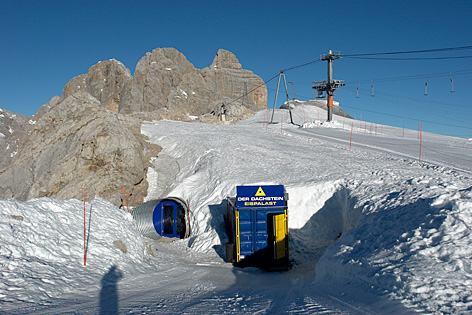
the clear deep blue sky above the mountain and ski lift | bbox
[0,0,472,138]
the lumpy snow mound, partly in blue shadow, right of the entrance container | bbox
[316,179,472,313]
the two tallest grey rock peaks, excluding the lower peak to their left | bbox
[119,48,267,116]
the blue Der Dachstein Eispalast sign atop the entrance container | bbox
[236,185,285,208]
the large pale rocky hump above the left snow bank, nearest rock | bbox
[0,91,159,206]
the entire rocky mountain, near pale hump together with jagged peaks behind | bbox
[0,48,267,206]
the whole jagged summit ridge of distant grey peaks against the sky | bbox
[62,48,267,116]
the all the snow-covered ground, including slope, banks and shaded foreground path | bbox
[0,105,472,314]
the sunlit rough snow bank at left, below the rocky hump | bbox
[0,198,151,305]
